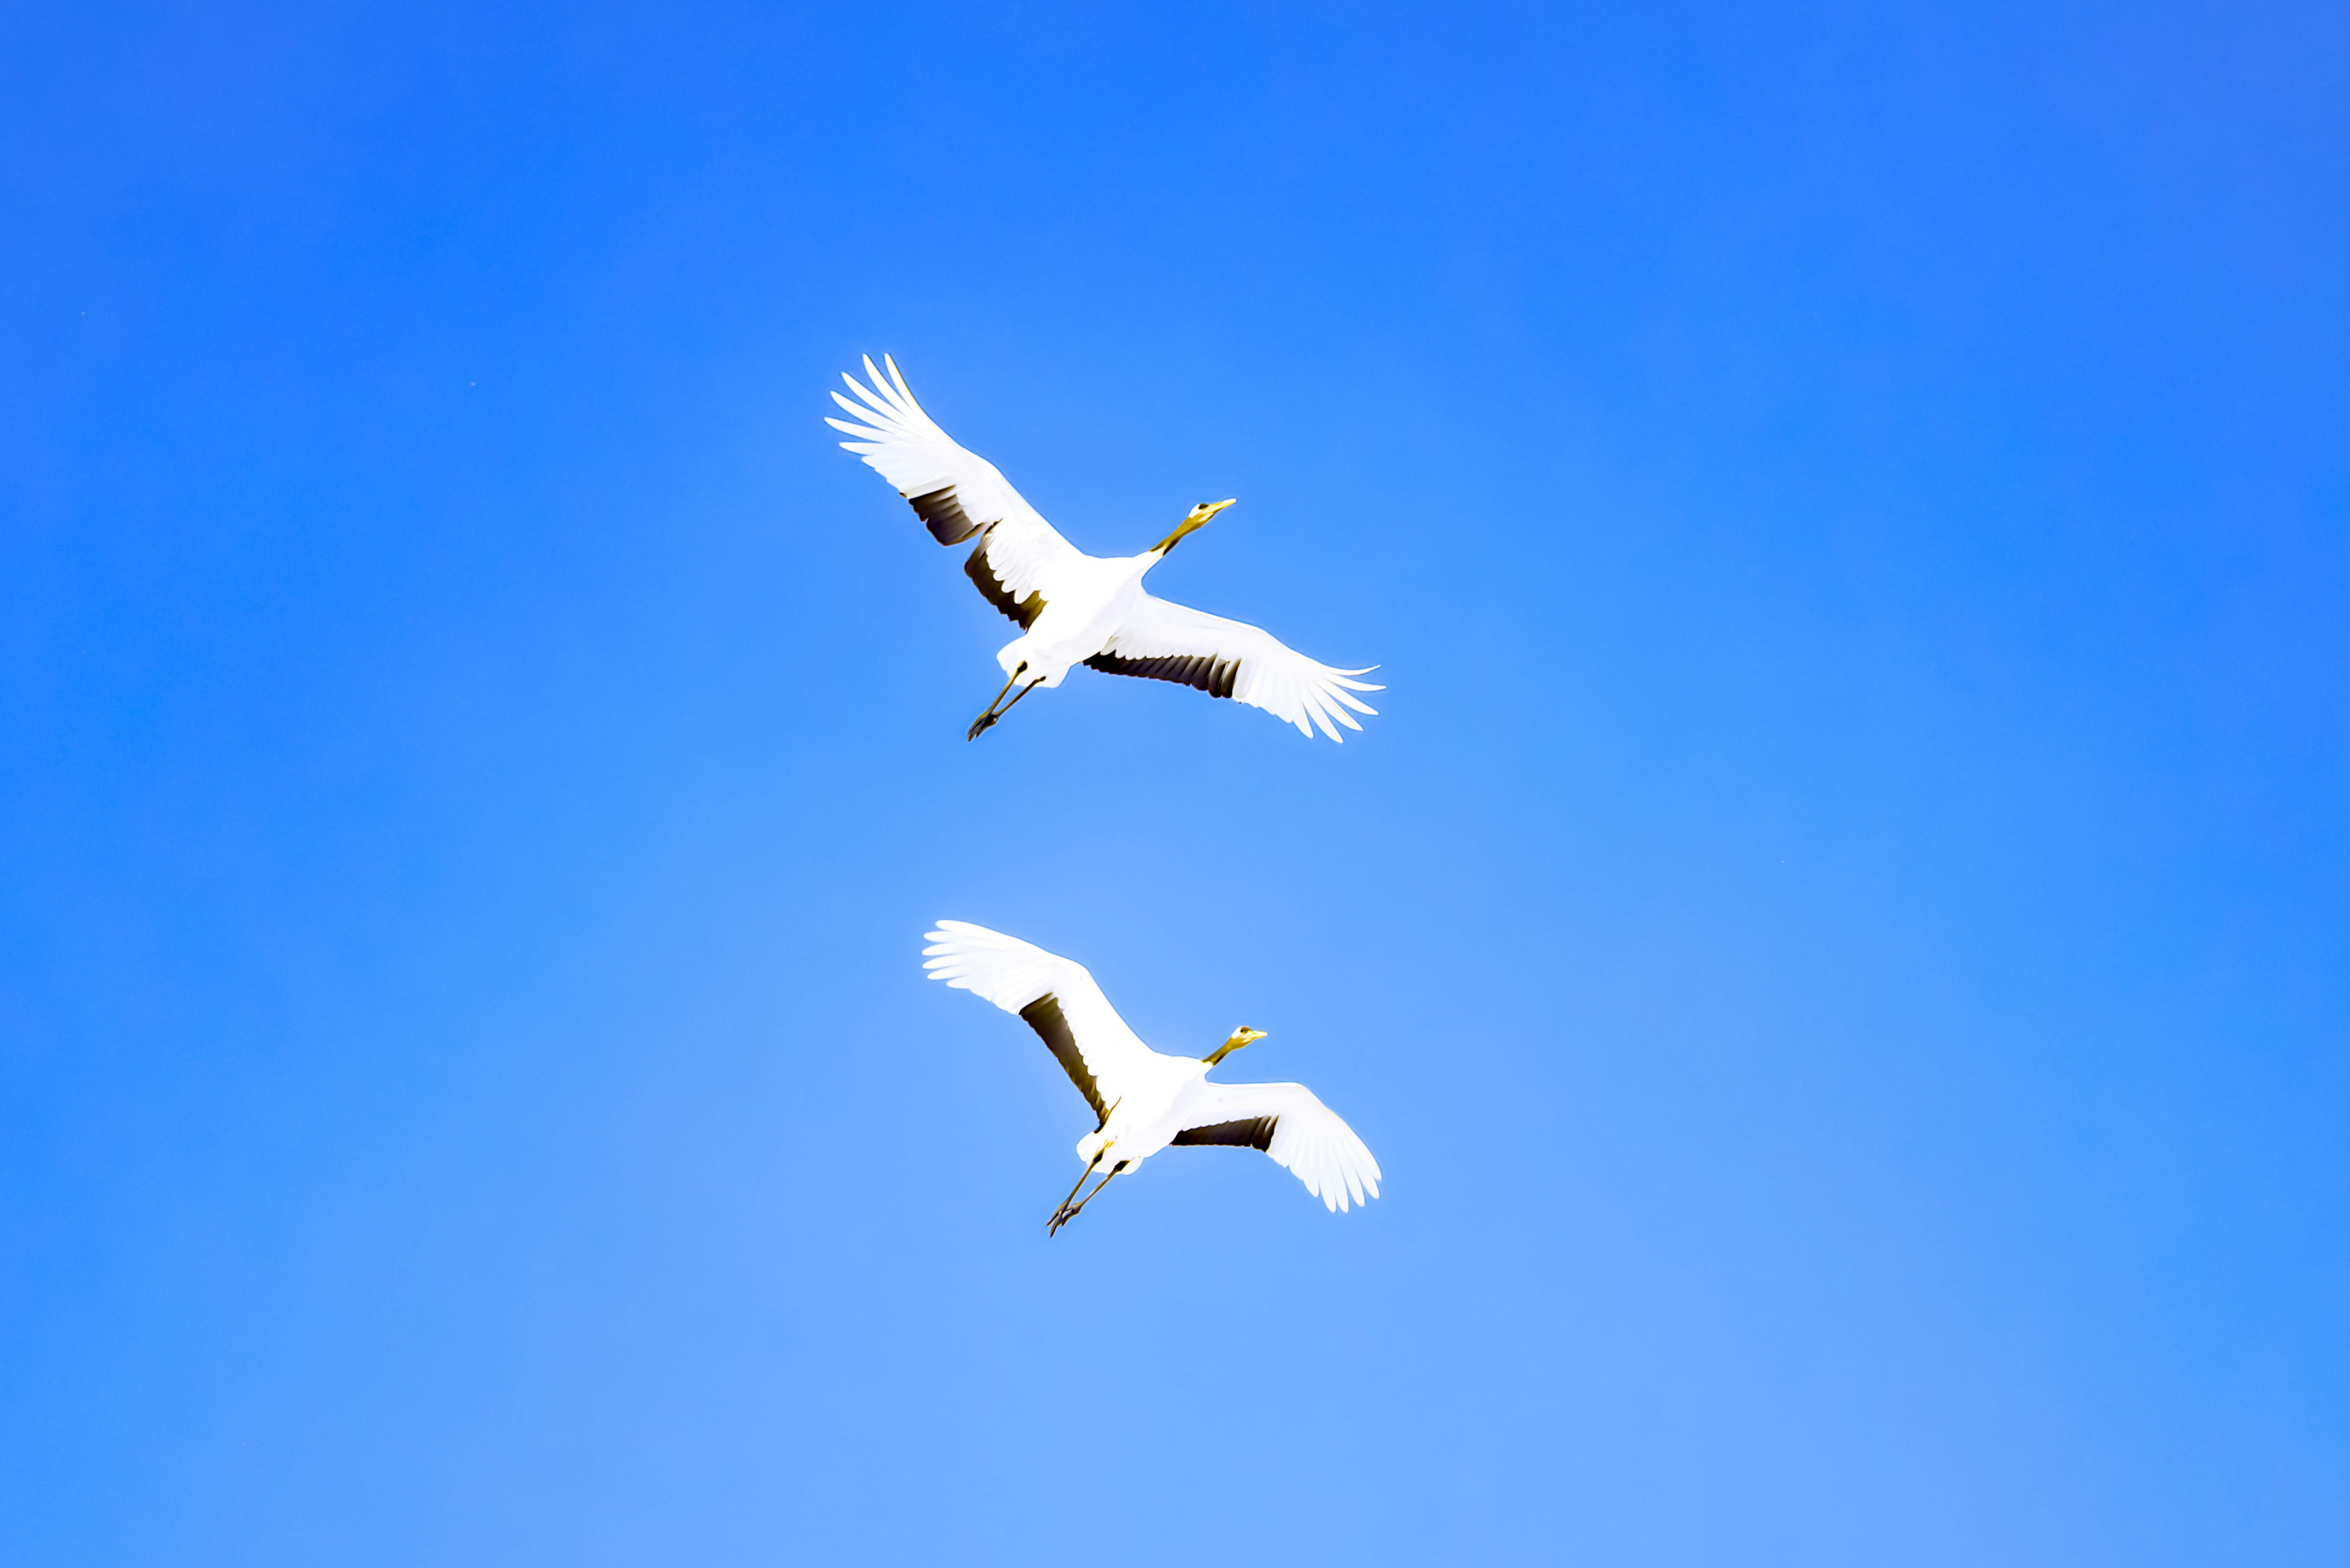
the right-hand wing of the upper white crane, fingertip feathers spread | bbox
[1086,592,1382,741]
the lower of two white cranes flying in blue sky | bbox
[921,919,1379,1234]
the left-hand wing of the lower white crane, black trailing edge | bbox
[921,919,1158,1129]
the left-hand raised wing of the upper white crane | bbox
[825,355,1076,630]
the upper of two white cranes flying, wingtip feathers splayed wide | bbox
[825,355,1382,741]
